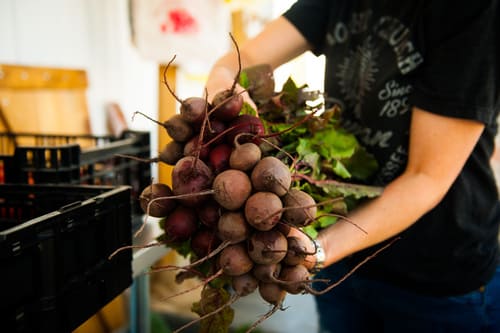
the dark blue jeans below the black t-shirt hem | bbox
[315,263,500,333]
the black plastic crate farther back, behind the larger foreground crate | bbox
[0,131,151,214]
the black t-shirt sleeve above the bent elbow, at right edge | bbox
[410,0,500,124]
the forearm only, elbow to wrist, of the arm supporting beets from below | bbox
[318,170,445,266]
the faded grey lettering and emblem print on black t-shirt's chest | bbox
[326,10,423,184]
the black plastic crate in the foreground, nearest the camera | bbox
[0,184,132,332]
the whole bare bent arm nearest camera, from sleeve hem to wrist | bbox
[318,108,484,266]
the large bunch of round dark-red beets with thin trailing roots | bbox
[133,65,336,331]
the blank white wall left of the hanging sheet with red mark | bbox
[0,0,158,134]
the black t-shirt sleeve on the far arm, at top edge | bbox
[283,0,332,55]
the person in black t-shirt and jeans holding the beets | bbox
[206,0,500,333]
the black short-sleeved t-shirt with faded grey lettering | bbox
[284,0,500,295]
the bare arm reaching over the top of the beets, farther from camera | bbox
[205,17,309,100]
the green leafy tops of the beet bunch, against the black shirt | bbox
[254,74,382,233]
